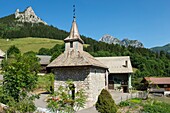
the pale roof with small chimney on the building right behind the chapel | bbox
[95,56,133,73]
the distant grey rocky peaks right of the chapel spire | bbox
[99,35,144,48]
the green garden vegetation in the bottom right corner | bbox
[117,98,170,113]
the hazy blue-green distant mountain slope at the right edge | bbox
[151,43,170,54]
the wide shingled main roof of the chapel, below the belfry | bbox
[47,50,107,69]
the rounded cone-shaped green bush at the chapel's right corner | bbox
[96,89,117,113]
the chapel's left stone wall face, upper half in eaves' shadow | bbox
[54,67,90,107]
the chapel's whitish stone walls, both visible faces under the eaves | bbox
[54,67,105,108]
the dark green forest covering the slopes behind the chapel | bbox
[0,15,170,88]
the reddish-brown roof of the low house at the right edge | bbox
[141,77,170,84]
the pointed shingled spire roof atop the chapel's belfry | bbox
[64,18,84,44]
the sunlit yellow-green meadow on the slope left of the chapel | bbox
[0,37,64,53]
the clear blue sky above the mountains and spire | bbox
[0,0,170,48]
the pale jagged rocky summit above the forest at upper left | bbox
[15,7,47,25]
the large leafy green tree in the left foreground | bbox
[0,47,40,113]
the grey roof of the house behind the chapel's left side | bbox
[36,55,51,65]
